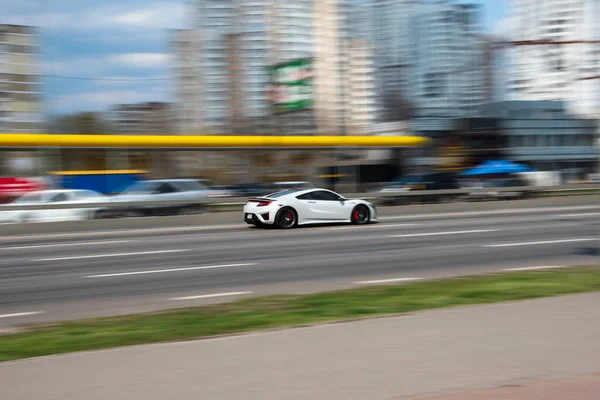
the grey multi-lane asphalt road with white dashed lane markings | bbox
[0,196,600,328]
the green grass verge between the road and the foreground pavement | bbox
[0,267,600,361]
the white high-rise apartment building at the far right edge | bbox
[509,0,600,118]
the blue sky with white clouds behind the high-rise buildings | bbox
[5,0,508,113]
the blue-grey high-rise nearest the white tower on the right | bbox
[409,1,489,117]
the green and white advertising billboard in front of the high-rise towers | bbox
[269,58,313,113]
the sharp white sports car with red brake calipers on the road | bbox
[244,189,377,229]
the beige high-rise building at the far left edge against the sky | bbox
[0,25,43,133]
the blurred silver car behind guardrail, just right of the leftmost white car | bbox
[101,179,210,217]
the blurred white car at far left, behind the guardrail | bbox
[0,189,107,223]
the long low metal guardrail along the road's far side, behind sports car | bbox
[0,183,600,211]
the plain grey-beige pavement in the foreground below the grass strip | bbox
[0,293,600,400]
